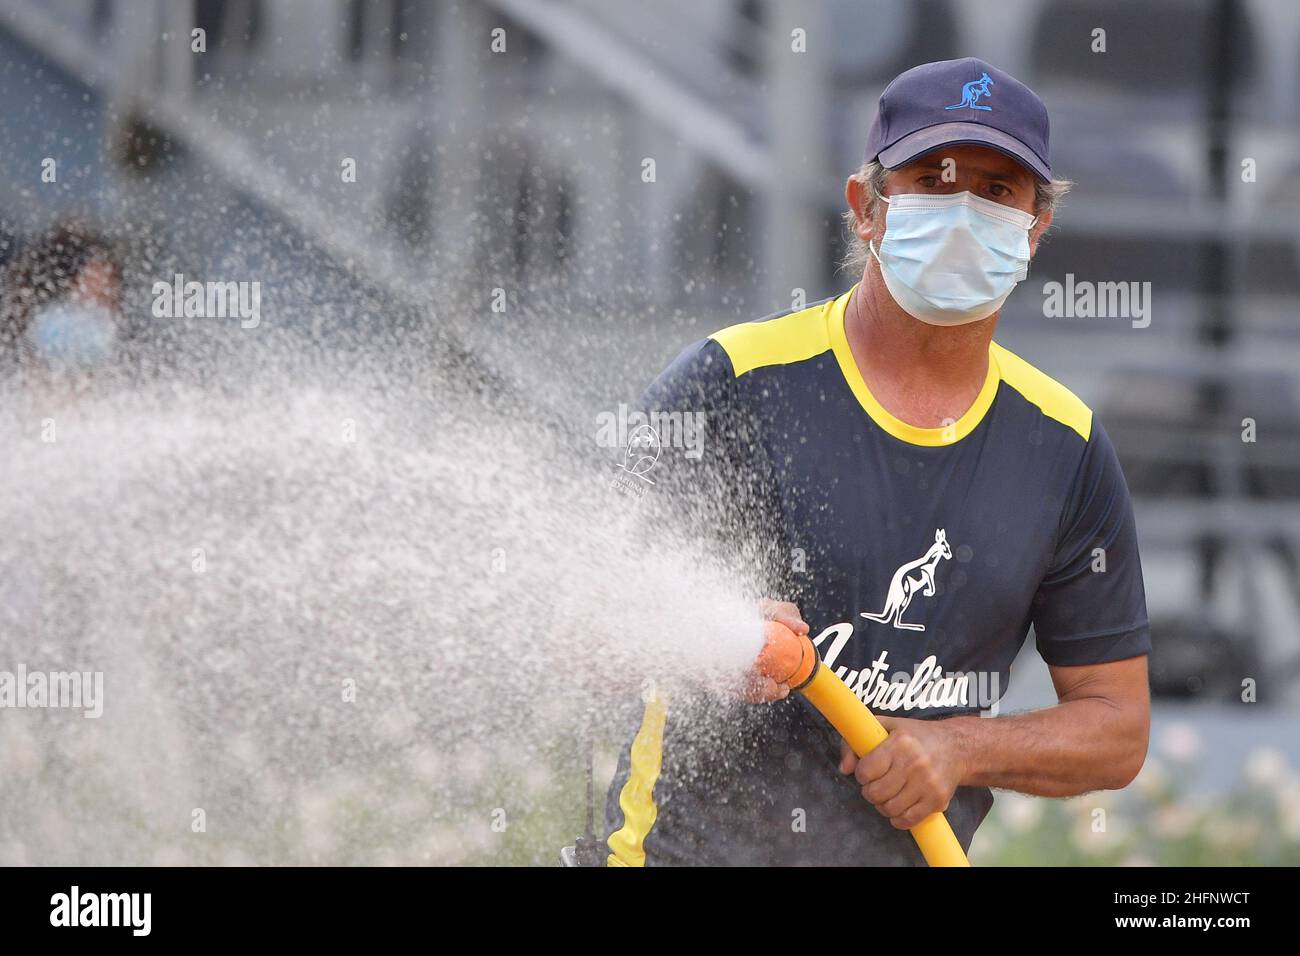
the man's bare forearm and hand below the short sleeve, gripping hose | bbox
[840,654,1151,830]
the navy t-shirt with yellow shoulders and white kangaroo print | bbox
[606,289,1151,865]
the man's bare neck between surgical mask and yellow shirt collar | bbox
[844,265,997,428]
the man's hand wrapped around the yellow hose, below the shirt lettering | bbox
[840,717,965,830]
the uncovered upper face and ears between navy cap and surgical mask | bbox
[849,144,1052,255]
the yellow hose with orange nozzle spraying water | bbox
[758,620,970,866]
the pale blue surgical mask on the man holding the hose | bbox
[868,193,1039,325]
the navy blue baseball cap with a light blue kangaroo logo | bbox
[867,56,1052,181]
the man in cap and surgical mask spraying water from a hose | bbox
[607,59,1151,865]
